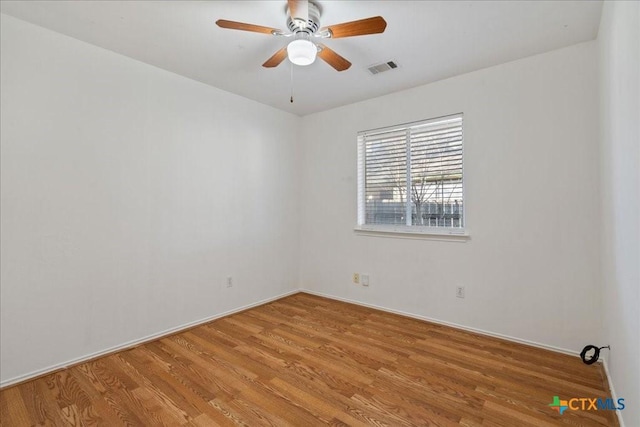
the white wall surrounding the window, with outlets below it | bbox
[300,42,601,351]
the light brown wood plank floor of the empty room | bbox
[0,293,617,426]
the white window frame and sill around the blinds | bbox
[354,113,470,242]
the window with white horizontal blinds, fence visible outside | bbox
[358,114,464,233]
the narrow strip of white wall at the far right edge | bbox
[598,2,640,426]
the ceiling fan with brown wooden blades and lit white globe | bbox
[216,0,387,71]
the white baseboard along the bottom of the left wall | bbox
[0,289,300,388]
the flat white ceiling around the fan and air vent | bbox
[0,0,602,115]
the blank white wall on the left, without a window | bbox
[0,15,299,384]
